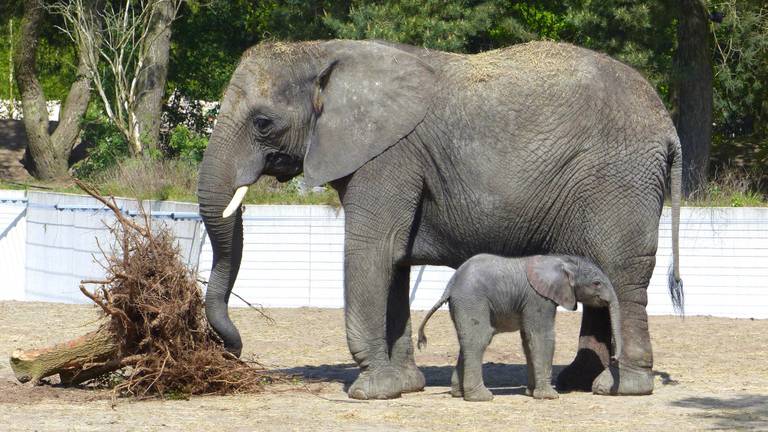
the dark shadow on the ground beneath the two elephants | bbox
[277,363,565,395]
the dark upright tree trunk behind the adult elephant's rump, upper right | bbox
[674,0,713,197]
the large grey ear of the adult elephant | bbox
[304,41,435,186]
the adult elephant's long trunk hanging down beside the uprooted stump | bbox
[197,120,263,356]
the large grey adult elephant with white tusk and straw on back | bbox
[198,40,681,399]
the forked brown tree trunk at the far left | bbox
[14,0,90,180]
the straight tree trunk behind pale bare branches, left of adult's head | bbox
[136,0,176,151]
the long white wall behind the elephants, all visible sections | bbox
[0,191,768,318]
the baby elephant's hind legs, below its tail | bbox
[451,304,493,402]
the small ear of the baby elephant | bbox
[525,255,576,310]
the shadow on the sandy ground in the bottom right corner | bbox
[671,394,768,430]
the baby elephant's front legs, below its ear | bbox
[521,317,559,399]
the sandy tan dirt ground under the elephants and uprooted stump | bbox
[0,302,768,431]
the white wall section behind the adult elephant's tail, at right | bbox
[648,207,768,318]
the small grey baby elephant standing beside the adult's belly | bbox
[418,254,621,401]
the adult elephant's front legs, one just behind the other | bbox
[339,152,424,399]
